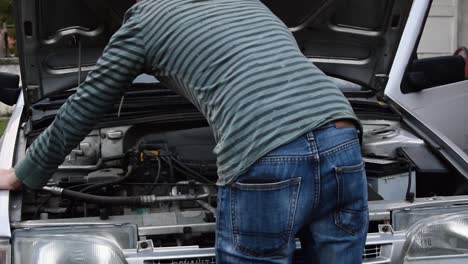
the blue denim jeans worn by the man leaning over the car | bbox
[216,125,368,264]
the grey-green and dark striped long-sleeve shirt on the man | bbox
[15,0,358,188]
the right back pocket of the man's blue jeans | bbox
[335,162,368,235]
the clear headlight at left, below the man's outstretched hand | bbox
[12,225,137,264]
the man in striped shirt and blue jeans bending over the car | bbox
[0,0,368,263]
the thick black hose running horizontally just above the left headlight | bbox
[62,189,142,207]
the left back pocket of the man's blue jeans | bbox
[231,178,301,257]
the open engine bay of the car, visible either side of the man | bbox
[12,114,460,251]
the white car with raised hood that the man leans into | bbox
[0,0,468,264]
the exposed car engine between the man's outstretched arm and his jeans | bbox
[16,124,217,245]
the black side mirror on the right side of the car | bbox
[401,55,466,93]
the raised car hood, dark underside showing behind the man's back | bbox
[16,0,413,104]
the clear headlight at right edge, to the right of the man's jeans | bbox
[404,214,468,263]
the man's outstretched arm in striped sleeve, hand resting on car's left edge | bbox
[7,14,146,189]
